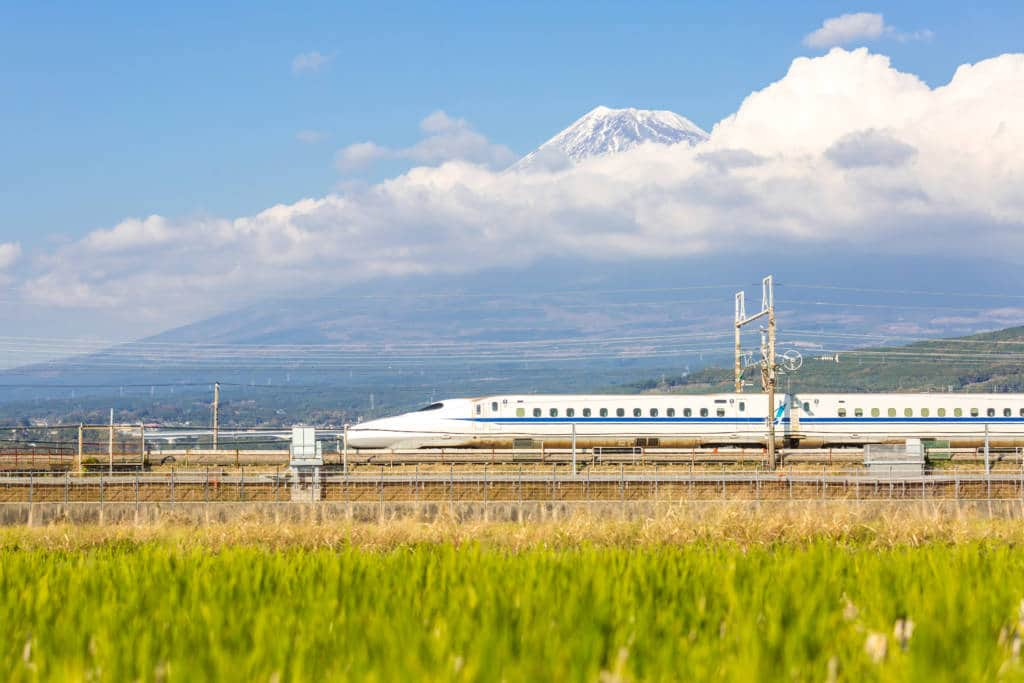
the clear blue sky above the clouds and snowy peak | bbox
[0,1,1024,252]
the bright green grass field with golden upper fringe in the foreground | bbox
[6,517,1024,681]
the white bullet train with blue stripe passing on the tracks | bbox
[347,393,1024,449]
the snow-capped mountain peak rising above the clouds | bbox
[511,106,708,171]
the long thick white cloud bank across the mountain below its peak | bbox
[16,48,1024,322]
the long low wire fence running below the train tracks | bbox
[0,465,1024,503]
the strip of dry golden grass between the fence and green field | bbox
[0,504,1024,551]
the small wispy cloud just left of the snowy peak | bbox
[335,110,516,173]
